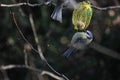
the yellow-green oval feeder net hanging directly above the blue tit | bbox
[72,0,92,30]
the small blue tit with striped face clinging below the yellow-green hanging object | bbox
[63,30,93,58]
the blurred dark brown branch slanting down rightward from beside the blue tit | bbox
[89,42,120,60]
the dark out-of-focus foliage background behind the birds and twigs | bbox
[0,0,120,80]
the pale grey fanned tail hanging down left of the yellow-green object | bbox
[51,6,62,23]
